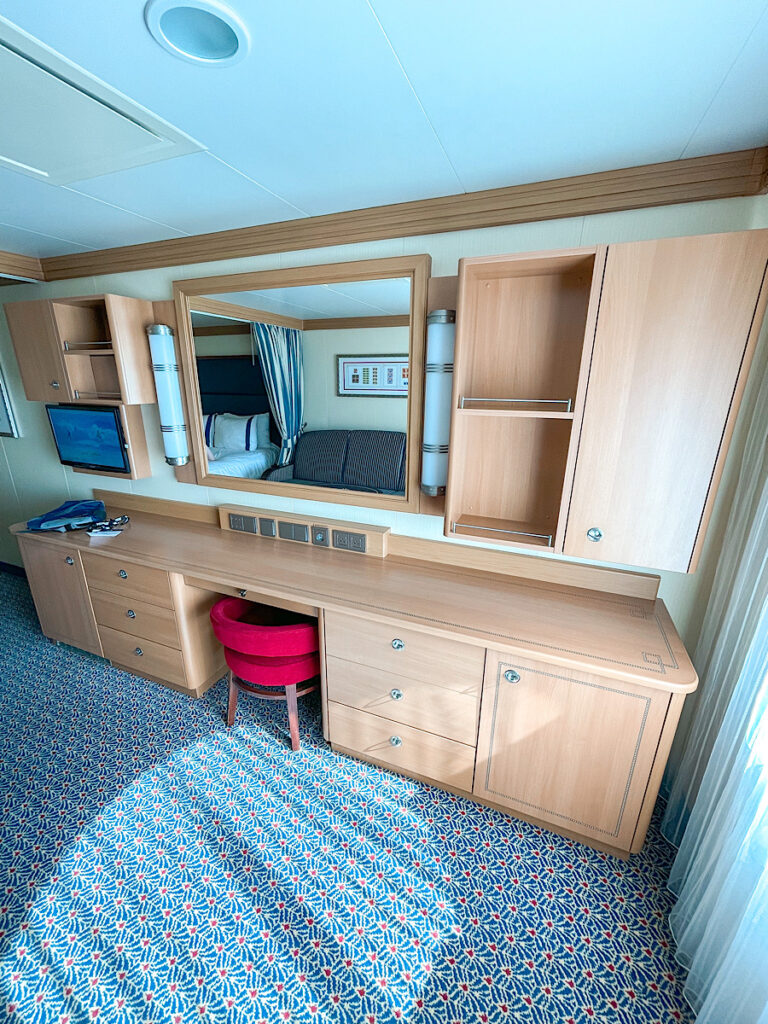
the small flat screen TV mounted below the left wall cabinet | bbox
[45,406,131,473]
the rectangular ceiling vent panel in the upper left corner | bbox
[0,17,205,185]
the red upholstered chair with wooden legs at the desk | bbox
[211,597,319,751]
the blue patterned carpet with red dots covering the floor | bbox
[0,573,692,1024]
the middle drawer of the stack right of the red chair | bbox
[326,656,479,746]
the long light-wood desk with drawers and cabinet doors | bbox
[13,514,697,855]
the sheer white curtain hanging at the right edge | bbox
[663,362,768,1024]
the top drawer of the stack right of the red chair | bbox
[326,611,485,693]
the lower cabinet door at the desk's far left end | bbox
[17,537,101,654]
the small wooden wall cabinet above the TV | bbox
[5,295,156,406]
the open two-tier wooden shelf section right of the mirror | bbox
[445,250,596,551]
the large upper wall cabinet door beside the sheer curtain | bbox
[564,230,768,572]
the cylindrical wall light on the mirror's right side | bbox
[421,309,456,496]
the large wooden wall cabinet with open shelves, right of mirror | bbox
[445,230,768,572]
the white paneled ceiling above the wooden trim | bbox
[0,0,768,256]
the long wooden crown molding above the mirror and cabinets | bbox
[41,146,768,281]
